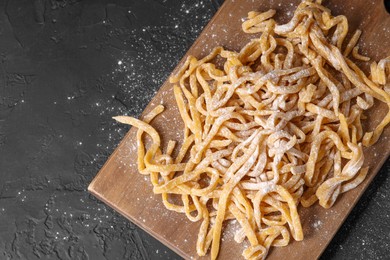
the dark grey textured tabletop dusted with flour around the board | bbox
[0,0,390,259]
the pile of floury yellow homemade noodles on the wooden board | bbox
[115,1,390,259]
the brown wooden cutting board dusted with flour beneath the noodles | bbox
[88,0,390,259]
